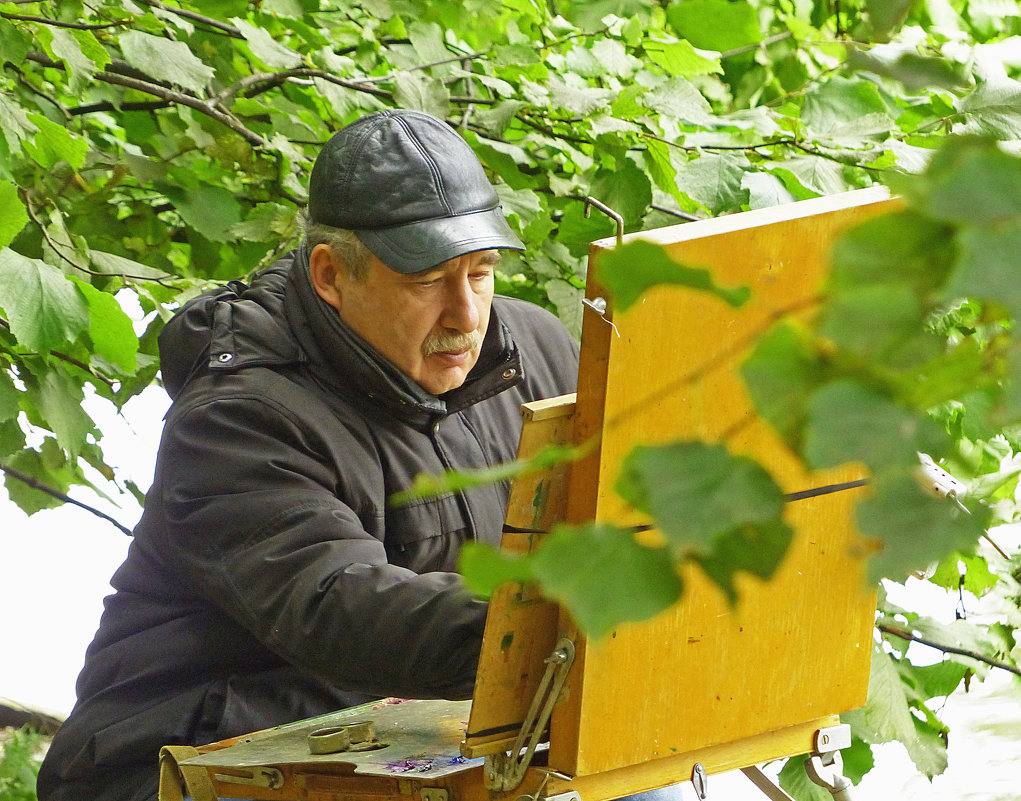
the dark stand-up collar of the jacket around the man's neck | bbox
[285,243,522,427]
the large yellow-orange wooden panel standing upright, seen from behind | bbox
[550,190,892,775]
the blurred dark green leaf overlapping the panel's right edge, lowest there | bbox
[855,471,987,581]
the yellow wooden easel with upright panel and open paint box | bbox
[159,190,893,801]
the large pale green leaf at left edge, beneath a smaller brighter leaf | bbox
[0,248,89,353]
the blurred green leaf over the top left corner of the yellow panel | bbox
[599,240,751,311]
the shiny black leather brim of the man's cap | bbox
[354,207,525,273]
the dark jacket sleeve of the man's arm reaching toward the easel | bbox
[150,377,486,698]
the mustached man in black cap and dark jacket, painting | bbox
[39,111,578,801]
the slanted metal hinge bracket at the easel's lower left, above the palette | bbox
[483,638,575,792]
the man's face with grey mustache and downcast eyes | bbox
[324,244,499,395]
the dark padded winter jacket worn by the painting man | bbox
[39,249,577,801]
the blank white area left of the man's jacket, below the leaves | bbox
[0,388,168,715]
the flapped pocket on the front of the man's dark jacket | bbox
[383,493,473,572]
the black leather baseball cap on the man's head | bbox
[308,110,525,273]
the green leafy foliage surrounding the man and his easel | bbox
[0,0,1021,795]
